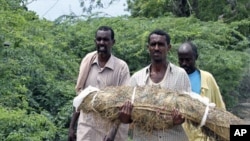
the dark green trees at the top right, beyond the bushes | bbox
[127,0,250,22]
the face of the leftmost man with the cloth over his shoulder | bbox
[95,30,114,54]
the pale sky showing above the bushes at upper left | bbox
[27,0,129,21]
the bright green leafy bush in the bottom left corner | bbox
[0,106,57,141]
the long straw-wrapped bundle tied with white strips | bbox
[75,86,245,140]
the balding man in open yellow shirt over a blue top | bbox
[178,42,226,141]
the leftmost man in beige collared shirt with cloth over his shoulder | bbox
[68,26,130,141]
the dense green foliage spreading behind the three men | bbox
[0,0,250,141]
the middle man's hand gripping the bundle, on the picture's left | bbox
[119,101,133,124]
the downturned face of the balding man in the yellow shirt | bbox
[178,49,196,74]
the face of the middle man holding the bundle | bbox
[148,34,171,62]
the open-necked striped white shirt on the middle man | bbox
[129,63,191,141]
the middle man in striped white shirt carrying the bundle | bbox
[130,30,191,141]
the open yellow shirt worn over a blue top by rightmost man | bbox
[182,70,226,141]
